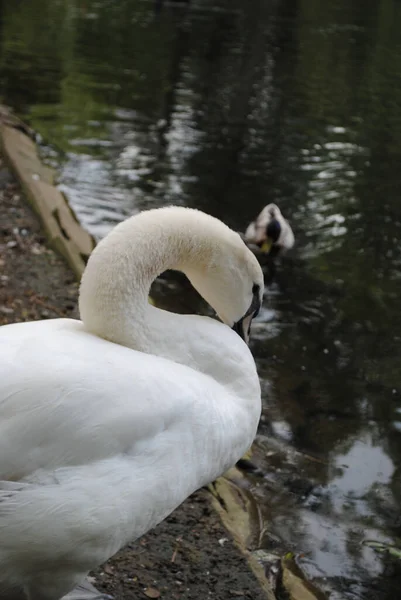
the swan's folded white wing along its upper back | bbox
[0,320,238,481]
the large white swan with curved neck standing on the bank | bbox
[0,207,263,600]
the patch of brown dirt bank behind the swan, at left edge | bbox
[0,159,78,325]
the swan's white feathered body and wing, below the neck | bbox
[0,320,254,582]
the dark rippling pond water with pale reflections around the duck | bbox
[0,0,401,600]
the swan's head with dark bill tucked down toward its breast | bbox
[183,213,264,343]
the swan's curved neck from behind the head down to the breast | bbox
[79,213,260,410]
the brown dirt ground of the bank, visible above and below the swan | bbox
[0,160,265,600]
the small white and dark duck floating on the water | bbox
[244,203,295,257]
